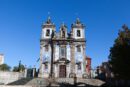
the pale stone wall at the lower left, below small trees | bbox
[0,71,24,84]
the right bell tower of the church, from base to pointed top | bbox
[71,18,86,77]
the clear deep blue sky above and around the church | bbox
[0,0,130,68]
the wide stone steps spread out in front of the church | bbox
[8,78,104,87]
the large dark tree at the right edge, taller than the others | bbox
[109,25,130,80]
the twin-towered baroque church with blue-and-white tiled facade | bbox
[38,17,87,78]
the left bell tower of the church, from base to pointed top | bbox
[38,17,55,77]
